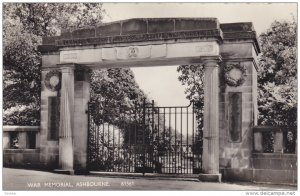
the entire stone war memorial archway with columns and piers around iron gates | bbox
[38,18,260,181]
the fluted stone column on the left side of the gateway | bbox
[59,65,74,174]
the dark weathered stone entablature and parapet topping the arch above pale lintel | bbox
[39,18,260,53]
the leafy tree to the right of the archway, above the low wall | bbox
[258,21,297,129]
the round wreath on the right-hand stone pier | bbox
[224,63,247,87]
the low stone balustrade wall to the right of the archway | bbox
[252,126,297,184]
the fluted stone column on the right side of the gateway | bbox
[200,58,221,182]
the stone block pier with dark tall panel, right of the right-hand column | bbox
[219,40,257,181]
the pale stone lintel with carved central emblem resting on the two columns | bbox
[57,41,220,68]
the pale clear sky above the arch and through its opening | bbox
[103,3,297,106]
